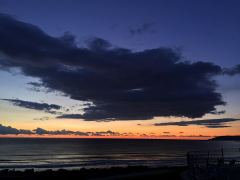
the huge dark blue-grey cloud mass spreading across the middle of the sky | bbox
[0,15,231,121]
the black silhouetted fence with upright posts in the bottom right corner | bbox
[187,148,240,180]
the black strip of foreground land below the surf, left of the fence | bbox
[0,166,186,180]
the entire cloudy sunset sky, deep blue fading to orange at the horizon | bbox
[0,0,240,139]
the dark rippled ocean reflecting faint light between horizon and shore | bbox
[0,138,240,169]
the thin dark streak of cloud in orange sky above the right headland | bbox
[154,118,240,128]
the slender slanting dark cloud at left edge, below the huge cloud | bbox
[1,99,61,114]
